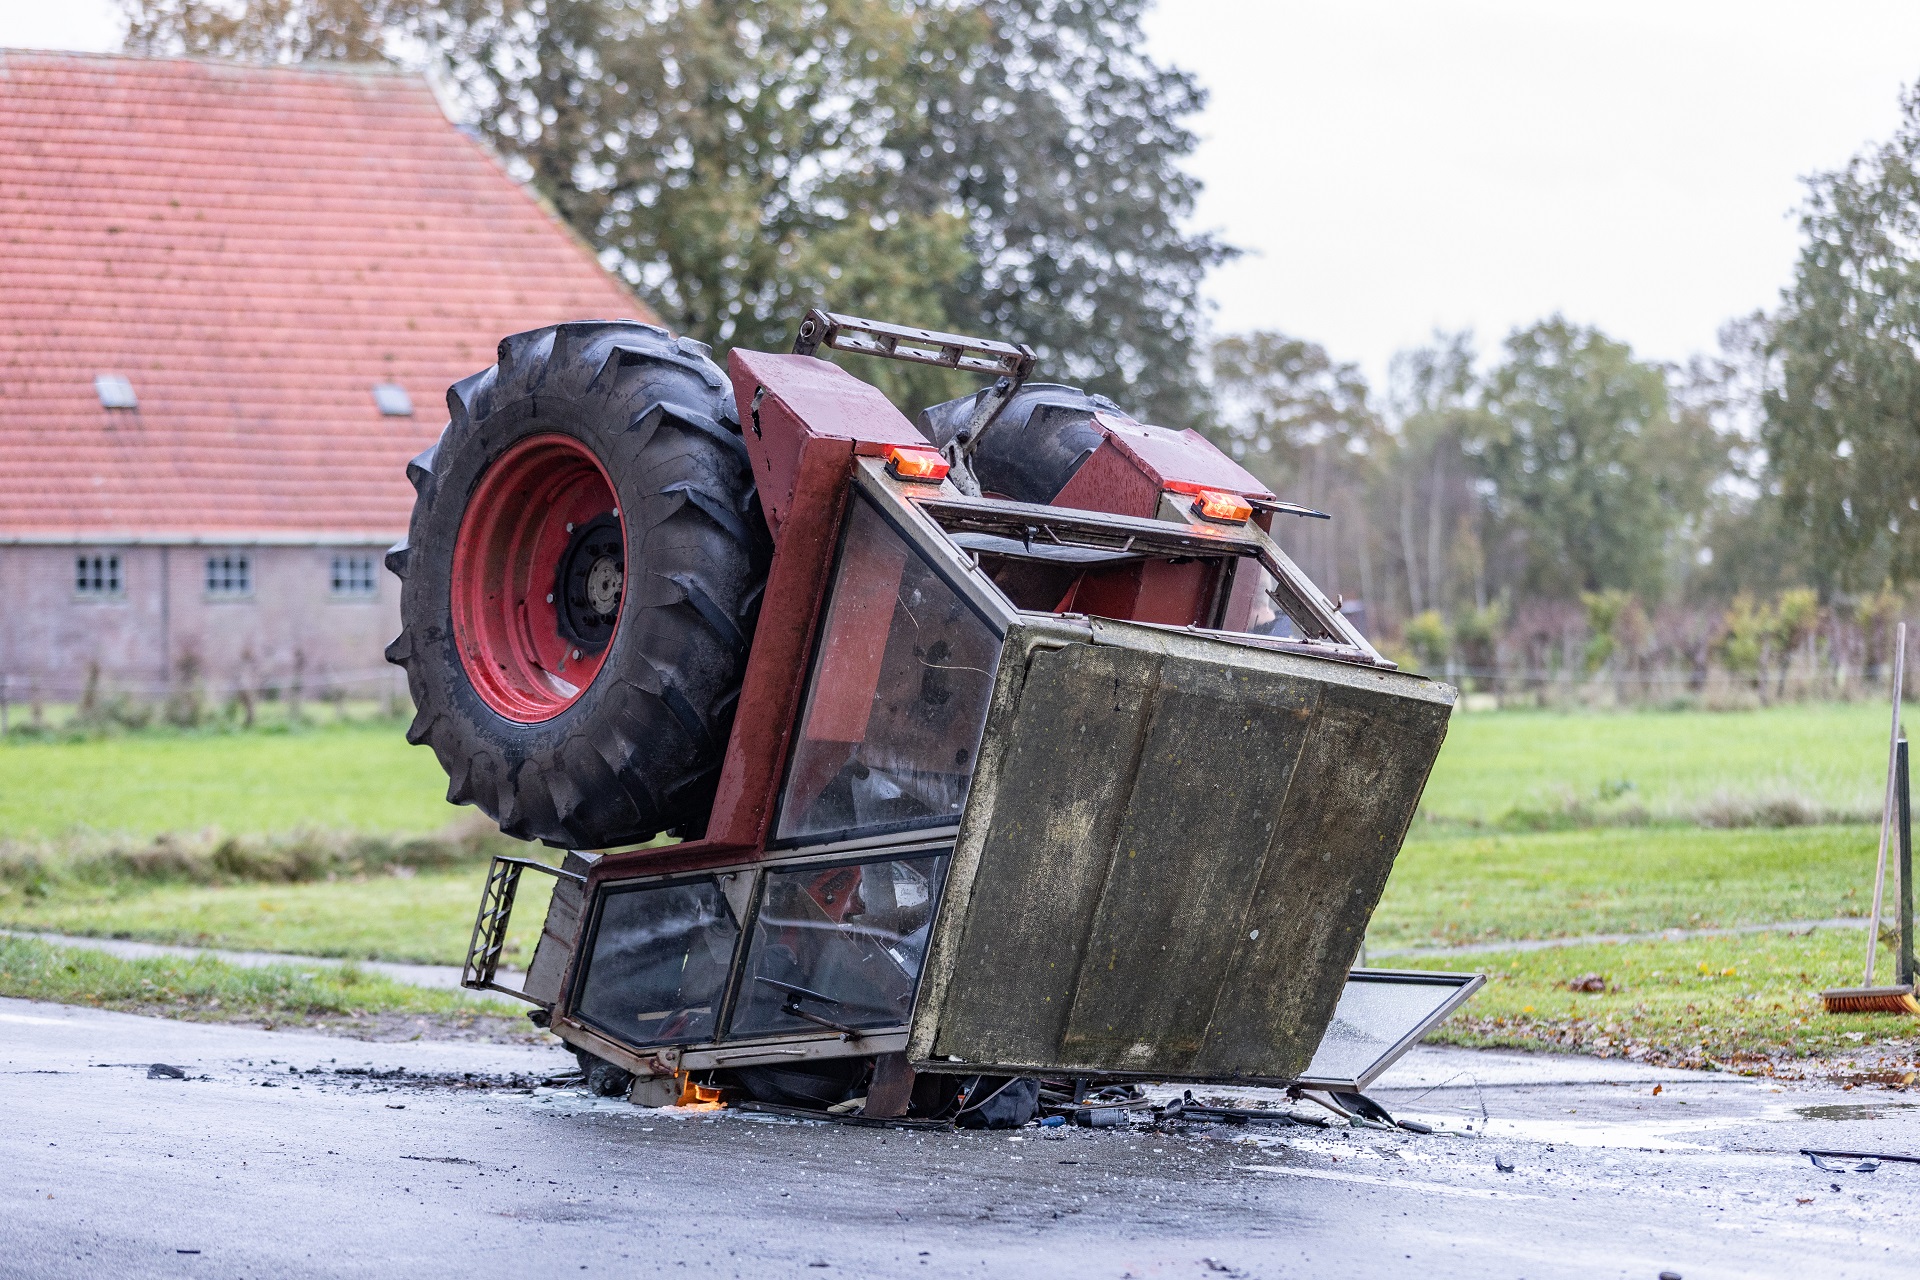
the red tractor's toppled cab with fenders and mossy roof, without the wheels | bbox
[449,313,1480,1115]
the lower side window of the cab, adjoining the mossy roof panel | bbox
[728,852,947,1036]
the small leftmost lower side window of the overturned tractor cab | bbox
[576,879,739,1046]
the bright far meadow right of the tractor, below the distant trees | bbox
[1421,702,1887,825]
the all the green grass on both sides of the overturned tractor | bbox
[0,704,1907,1061]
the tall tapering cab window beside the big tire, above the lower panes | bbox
[774,497,1000,844]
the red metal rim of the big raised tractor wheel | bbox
[453,436,626,723]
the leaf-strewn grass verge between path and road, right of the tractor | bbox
[1396,929,1914,1082]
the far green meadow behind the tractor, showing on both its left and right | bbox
[0,702,1885,841]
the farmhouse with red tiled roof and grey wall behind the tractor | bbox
[0,52,651,702]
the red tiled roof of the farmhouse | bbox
[0,52,651,541]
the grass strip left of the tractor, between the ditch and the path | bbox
[0,864,553,967]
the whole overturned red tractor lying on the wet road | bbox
[388,311,1478,1123]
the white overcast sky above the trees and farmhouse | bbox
[0,0,1920,378]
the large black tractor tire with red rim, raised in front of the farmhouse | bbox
[386,320,770,848]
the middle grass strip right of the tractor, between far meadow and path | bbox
[1367,827,1880,946]
